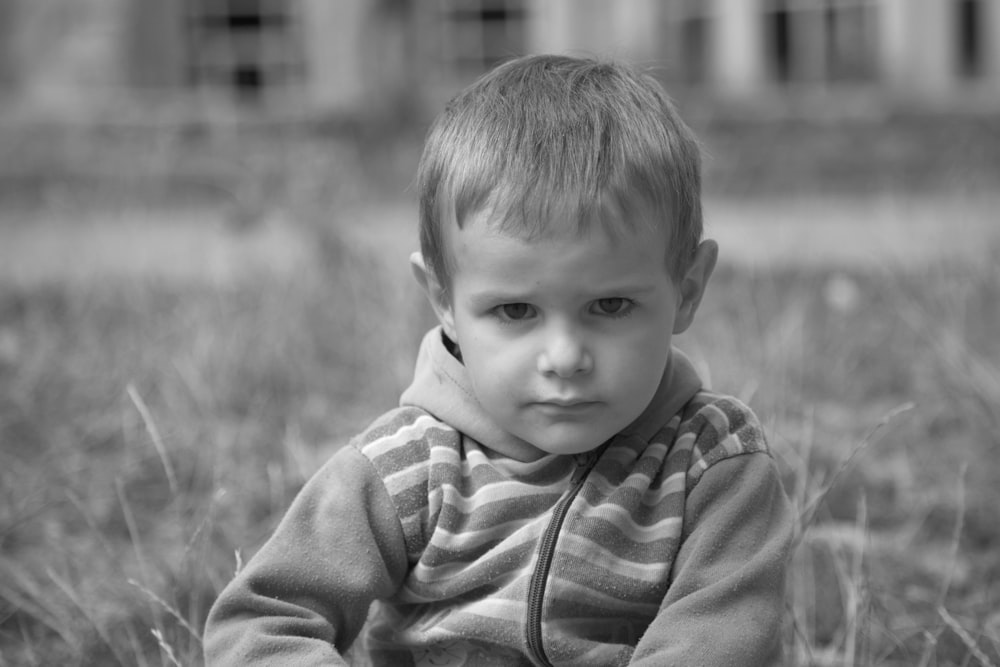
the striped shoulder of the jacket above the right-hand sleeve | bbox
[677,391,770,486]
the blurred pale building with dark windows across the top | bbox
[0,0,1000,122]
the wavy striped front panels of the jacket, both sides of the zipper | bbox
[353,391,767,665]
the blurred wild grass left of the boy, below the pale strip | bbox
[0,228,432,665]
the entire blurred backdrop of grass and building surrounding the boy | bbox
[0,0,1000,665]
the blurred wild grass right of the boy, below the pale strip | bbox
[693,267,1000,665]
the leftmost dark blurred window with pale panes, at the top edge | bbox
[186,0,305,104]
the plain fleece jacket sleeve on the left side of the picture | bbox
[204,446,407,667]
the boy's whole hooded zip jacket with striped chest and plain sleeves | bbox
[205,332,793,666]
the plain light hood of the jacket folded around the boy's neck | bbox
[399,326,701,461]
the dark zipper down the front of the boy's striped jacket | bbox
[525,443,607,667]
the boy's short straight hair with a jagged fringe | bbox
[417,55,702,288]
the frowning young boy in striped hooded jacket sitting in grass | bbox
[205,56,793,667]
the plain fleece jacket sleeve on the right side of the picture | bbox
[632,452,795,667]
